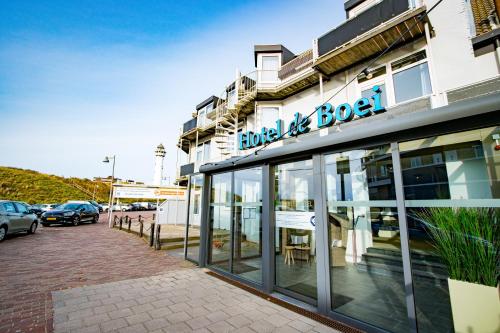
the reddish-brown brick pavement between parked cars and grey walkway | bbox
[0,215,191,333]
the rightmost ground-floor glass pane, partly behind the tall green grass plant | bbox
[400,127,500,332]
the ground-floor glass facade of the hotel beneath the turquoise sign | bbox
[196,127,500,332]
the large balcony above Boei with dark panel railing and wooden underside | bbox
[313,0,425,75]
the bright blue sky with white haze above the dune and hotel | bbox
[0,0,345,182]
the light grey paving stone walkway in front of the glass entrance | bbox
[52,268,338,333]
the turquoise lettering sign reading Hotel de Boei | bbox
[238,86,385,150]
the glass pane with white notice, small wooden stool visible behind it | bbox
[275,160,317,299]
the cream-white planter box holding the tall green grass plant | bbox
[448,279,500,333]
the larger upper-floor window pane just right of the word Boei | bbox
[391,51,432,103]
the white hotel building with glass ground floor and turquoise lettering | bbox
[178,0,500,332]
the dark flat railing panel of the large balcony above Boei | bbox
[318,0,409,56]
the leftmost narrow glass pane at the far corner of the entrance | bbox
[186,175,203,263]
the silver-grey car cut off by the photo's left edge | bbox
[0,200,38,242]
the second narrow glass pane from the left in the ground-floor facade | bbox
[208,172,232,271]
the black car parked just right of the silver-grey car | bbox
[41,203,99,227]
